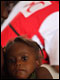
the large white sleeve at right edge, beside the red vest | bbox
[39,12,59,65]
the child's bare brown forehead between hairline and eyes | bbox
[6,42,35,55]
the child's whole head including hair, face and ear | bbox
[5,37,43,79]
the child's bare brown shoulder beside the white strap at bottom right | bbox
[36,67,53,79]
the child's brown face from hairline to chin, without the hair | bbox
[7,42,36,79]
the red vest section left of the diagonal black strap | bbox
[1,26,17,47]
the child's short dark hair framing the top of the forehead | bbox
[6,36,43,59]
